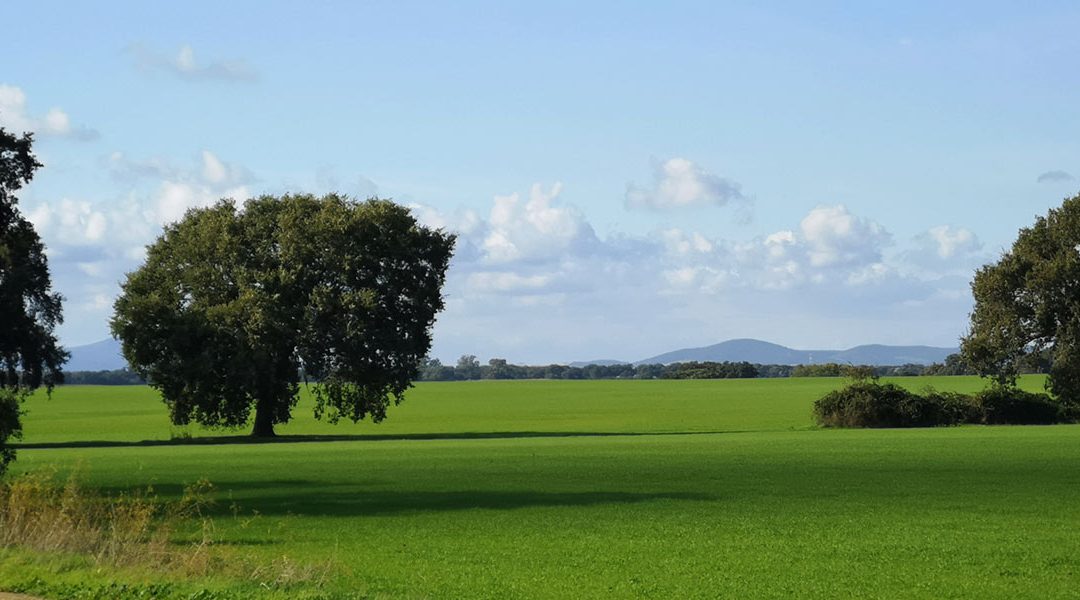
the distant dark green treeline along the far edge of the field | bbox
[56,354,1019,385]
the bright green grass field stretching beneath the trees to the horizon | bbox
[0,378,1080,598]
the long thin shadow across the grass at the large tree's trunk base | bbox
[9,429,745,450]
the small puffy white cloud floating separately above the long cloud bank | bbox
[625,158,748,209]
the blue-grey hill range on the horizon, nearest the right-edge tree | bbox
[634,339,959,366]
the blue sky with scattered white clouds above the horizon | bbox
[0,1,1080,363]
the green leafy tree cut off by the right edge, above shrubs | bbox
[961,195,1080,406]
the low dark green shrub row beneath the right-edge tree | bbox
[813,379,1069,427]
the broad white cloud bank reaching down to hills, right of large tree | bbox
[414,186,978,362]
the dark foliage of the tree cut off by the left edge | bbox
[0,127,67,474]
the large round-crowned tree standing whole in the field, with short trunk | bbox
[111,194,455,436]
